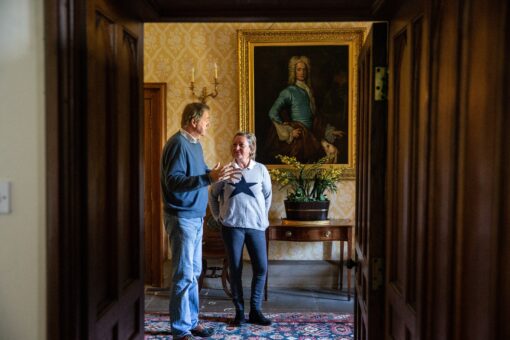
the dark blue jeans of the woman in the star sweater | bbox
[221,227,267,312]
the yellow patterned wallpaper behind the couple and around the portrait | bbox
[144,22,370,260]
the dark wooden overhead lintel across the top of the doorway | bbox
[127,0,397,22]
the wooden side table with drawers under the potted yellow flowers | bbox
[265,219,353,300]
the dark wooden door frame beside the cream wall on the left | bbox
[44,0,86,339]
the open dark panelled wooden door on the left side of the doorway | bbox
[85,0,144,339]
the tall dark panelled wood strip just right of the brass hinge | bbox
[385,2,429,340]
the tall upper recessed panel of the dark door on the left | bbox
[114,27,139,290]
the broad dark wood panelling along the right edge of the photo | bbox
[454,1,510,339]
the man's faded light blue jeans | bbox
[164,214,203,337]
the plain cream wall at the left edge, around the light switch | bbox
[0,0,46,340]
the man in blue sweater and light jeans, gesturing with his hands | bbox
[161,103,240,339]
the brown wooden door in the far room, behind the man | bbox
[143,83,168,287]
